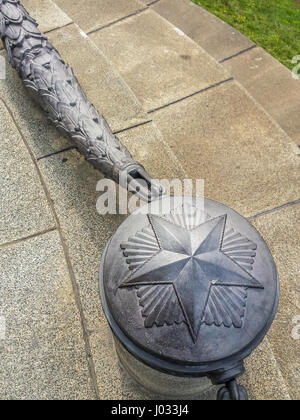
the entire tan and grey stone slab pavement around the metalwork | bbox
[0,0,300,400]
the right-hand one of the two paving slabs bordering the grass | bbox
[223,48,300,145]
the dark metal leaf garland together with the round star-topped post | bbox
[0,0,279,400]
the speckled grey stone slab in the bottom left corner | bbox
[0,231,95,400]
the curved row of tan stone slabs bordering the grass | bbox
[151,0,300,145]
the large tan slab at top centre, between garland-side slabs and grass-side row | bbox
[90,10,229,111]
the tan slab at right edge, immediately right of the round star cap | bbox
[253,204,300,400]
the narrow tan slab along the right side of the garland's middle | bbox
[49,25,149,131]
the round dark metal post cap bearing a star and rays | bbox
[100,197,279,400]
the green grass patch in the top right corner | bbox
[192,0,300,69]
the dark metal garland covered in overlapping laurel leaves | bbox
[0,0,162,200]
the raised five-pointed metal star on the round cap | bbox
[120,215,263,341]
